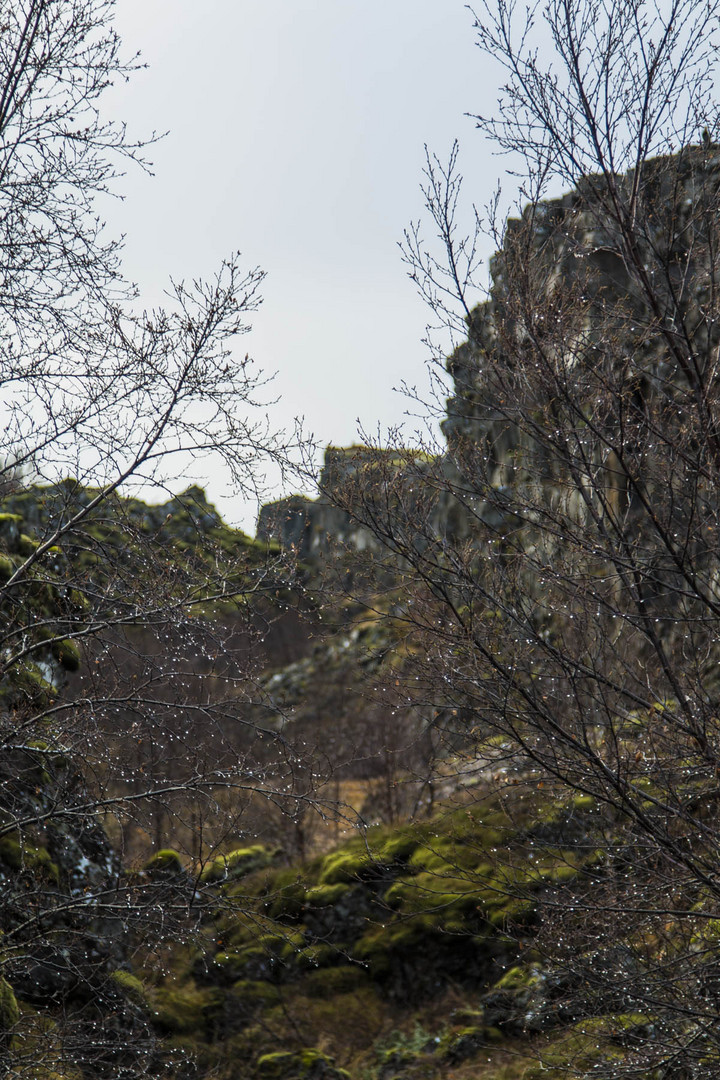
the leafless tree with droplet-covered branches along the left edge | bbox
[0,0,310,1077]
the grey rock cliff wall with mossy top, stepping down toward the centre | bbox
[258,146,720,558]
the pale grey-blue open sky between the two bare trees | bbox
[107,0,503,531]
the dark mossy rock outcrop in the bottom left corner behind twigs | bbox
[0,741,157,1078]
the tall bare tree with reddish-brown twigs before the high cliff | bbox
[332,0,720,1078]
